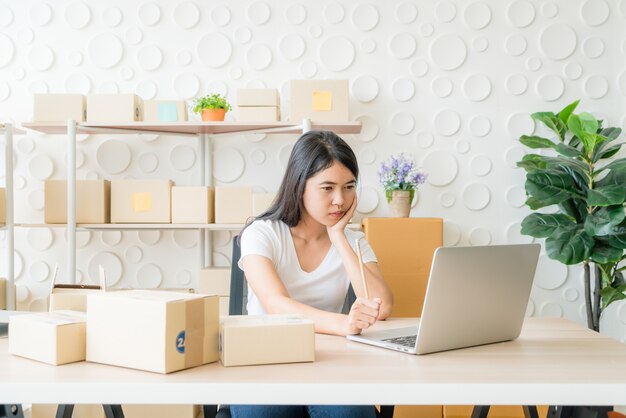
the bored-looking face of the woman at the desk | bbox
[302,162,356,226]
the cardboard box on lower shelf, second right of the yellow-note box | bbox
[215,187,252,224]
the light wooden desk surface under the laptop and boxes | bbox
[0,318,626,405]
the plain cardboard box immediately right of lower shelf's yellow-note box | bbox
[172,186,215,224]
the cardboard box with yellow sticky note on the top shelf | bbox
[289,80,350,122]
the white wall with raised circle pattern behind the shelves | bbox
[0,0,626,341]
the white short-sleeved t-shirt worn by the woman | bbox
[238,220,378,315]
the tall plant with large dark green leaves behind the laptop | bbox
[517,101,626,331]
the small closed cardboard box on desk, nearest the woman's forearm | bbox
[220,315,315,366]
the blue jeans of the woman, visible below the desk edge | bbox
[230,405,376,418]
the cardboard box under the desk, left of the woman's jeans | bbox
[31,404,201,418]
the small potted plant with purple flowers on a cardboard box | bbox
[378,153,426,218]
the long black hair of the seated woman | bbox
[239,131,359,236]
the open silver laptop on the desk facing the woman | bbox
[348,244,541,354]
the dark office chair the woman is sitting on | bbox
[204,235,394,418]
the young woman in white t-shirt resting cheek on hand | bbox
[231,131,393,418]
